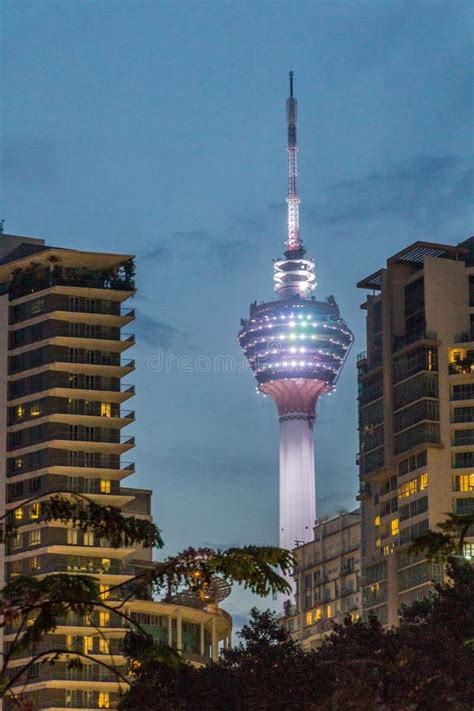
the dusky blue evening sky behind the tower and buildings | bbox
[1,0,474,623]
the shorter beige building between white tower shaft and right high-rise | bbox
[282,510,362,650]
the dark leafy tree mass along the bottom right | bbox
[120,516,474,711]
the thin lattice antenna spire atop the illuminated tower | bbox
[286,72,303,252]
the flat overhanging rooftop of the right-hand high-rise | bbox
[357,237,474,291]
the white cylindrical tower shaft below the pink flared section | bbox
[280,412,316,550]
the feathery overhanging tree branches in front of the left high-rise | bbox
[0,492,292,705]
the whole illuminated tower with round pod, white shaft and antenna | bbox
[239,72,353,549]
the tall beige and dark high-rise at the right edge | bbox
[358,238,474,625]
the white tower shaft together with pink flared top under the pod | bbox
[260,378,328,550]
